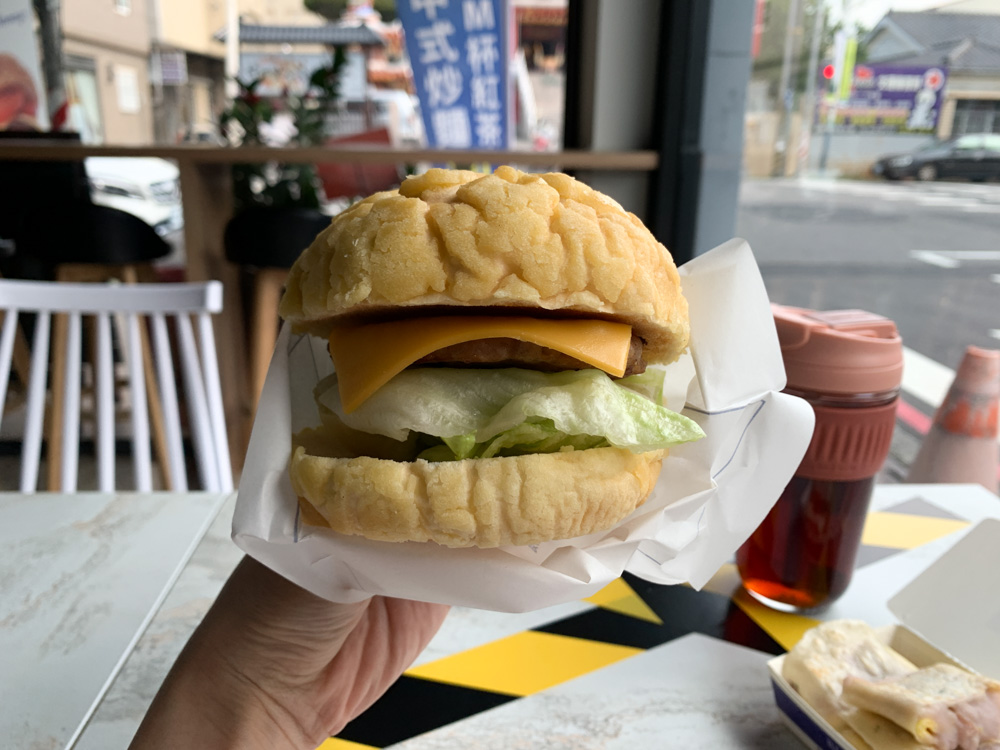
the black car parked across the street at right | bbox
[872,133,1000,181]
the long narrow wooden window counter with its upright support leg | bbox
[0,144,659,473]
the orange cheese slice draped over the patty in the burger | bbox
[330,316,632,413]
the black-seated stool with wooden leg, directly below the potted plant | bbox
[224,208,330,408]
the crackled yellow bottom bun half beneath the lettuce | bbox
[290,430,666,547]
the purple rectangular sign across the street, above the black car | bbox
[837,64,948,133]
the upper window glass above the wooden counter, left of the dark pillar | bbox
[25,0,569,151]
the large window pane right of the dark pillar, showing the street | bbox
[737,0,1000,478]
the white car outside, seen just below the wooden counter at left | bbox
[84,156,184,237]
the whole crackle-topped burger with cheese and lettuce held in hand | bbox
[280,167,703,547]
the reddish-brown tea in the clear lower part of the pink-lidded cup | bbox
[736,476,875,611]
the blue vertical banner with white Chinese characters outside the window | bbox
[396,0,510,149]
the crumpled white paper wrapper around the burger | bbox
[233,240,813,612]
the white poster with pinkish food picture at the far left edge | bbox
[0,0,49,130]
